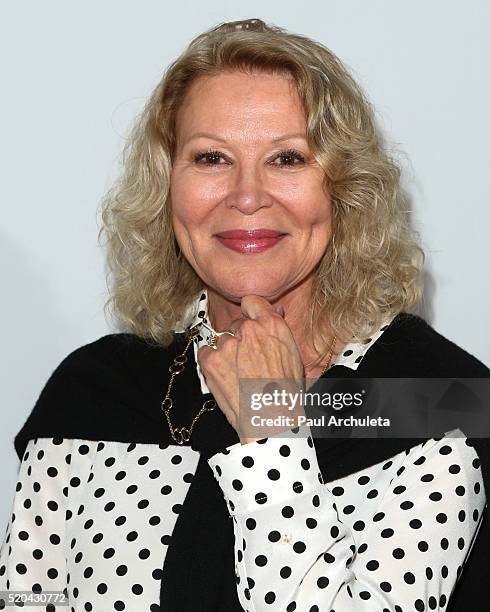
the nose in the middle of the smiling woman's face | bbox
[225,162,272,215]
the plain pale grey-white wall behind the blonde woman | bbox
[0,0,490,532]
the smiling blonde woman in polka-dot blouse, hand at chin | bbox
[0,19,490,612]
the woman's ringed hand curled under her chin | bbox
[197,295,304,444]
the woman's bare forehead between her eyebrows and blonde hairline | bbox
[176,71,305,141]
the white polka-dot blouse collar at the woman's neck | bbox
[174,289,394,394]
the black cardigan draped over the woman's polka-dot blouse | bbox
[14,313,490,612]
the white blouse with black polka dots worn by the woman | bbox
[0,293,486,612]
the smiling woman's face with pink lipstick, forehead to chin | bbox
[170,72,331,303]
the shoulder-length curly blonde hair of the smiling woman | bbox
[99,19,425,363]
